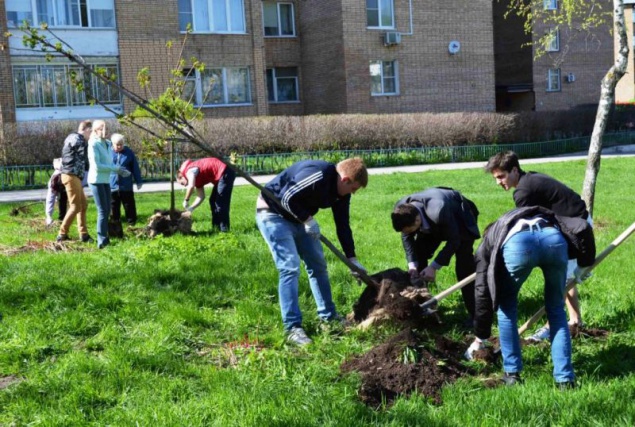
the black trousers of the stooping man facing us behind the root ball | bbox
[415,234,476,319]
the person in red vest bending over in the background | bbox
[177,157,236,233]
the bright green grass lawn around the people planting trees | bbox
[0,158,635,426]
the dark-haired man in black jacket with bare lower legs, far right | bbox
[485,151,593,341]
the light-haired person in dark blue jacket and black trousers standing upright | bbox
[110,133,143,225]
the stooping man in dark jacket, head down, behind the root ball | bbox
[391,187,480,325]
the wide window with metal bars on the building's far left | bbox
[11,62,123,111]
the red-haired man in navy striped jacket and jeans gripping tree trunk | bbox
[256,158,368,346]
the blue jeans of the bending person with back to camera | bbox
[497,226,575,382]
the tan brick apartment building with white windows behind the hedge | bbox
[0,0,628,128]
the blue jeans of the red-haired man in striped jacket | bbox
[256,212,337,331]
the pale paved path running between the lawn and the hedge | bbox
[0,145,635,203]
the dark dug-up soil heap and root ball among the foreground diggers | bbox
[341,269,470,408]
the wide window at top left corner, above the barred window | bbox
[5,0,117,29]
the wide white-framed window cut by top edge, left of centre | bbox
[177,0,247,34]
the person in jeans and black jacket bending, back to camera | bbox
[465,206,575,389]
